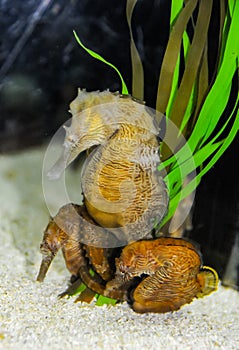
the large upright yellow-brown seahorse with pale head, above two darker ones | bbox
[50,89,168,245]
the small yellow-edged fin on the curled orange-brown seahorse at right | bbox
[196,266,219,298]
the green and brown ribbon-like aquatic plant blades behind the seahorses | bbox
[74,0,239,304]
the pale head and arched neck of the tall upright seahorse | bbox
[49,89,160,178]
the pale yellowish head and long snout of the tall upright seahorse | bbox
[48,89,119,179]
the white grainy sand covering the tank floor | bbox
[0,149,239,350]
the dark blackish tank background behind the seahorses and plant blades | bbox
[0,0,239,284]
